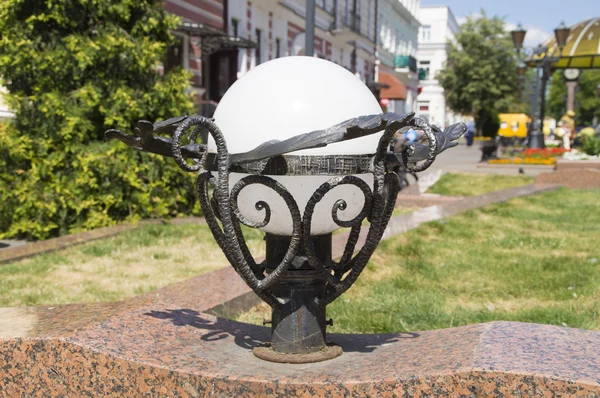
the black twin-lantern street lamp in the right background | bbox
[510,22,570,148]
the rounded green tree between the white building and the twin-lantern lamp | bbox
[437,11,523,135]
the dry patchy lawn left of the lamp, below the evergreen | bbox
[0,224,264,307]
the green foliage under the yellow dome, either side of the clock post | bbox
[548,69,600,125]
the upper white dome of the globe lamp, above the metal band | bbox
[208,57,381,155]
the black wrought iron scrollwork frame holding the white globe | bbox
[106,114,466,362]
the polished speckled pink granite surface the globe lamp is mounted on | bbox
[0,269,600,397]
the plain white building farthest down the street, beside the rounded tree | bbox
[417,6,462,127]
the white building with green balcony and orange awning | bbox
[377,0,421,113]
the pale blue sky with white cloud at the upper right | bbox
[421,0,600,46]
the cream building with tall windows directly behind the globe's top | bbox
[228,0,377,92]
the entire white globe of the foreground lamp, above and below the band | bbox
[208,57,381,236]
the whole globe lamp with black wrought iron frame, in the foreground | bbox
[106,57,466,363]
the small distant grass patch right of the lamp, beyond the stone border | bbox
[427,173,534,196]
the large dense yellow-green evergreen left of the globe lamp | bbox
[0,0,194,239]
